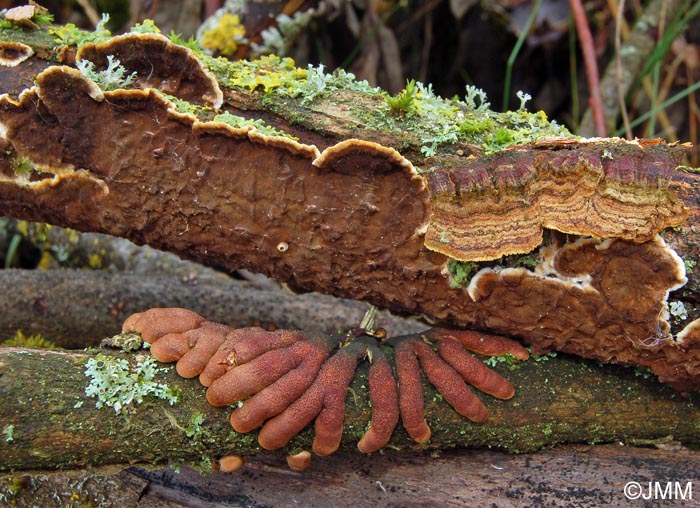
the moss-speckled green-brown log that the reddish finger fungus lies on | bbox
[0,348,700,470]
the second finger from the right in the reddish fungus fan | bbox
[438,337,515,399]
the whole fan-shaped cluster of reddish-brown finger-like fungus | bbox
[124,309,527,455]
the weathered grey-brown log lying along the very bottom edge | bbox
[0,443,698,508]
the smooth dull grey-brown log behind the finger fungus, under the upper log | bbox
[0,269,428,349]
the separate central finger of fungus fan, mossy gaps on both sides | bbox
[357,348,399,453]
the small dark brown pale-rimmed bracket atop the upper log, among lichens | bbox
[76,33,223,109]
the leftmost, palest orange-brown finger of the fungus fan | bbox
[122,307,205,342]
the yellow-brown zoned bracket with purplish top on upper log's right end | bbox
[425,140,687,261]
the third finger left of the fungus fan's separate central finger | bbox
[231,343,329,432]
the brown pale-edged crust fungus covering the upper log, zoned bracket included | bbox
[0,24,700,400]
